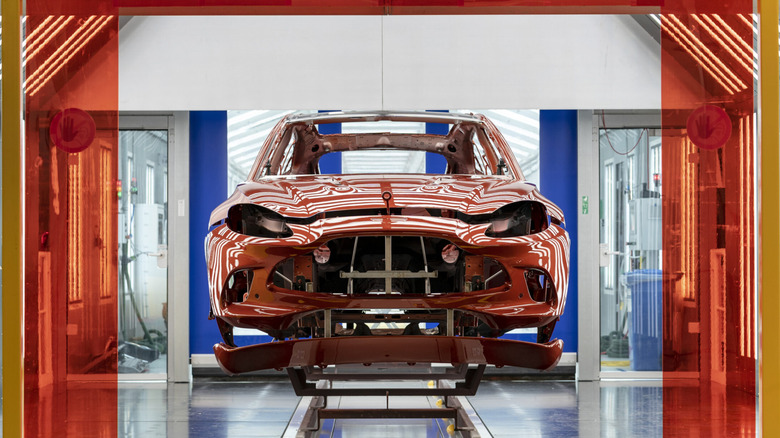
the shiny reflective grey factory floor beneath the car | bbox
[16,377,756,438]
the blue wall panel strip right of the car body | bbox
[539,110,577,352]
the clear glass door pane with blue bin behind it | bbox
[599,128,662,375]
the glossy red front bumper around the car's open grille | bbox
[206,216,569,332]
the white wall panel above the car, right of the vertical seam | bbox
[384,15,661,109]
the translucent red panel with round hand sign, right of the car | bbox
[661,0,757,437]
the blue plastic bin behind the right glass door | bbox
[625,269,663,371]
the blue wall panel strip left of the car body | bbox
[190,111,228,354]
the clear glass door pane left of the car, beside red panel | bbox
[116,129,169,379]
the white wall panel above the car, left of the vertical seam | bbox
[119,17,382,111]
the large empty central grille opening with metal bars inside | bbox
[270,236,509,295]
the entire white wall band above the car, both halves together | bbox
[119,15,661,110]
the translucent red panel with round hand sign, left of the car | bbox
[22,10,118,437]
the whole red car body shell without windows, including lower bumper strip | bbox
[206,111,570,374]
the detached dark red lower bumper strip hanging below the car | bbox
[214,336,563,375]
